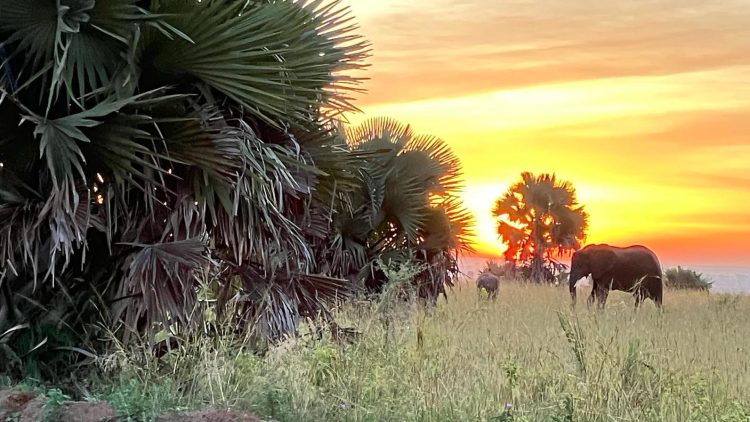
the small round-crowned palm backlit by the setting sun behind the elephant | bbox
[492,173,588,282]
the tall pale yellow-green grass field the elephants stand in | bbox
[89,284,750,421]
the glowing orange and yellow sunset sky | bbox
[344,0,750,264]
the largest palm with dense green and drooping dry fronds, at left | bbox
[0,0,368,376]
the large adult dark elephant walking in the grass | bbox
[569,245,662,308]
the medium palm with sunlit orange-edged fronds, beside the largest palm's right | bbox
[331,118,472,301]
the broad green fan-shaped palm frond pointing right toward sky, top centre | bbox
[142,0,366,122]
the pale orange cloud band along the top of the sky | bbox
[349,0,750,103]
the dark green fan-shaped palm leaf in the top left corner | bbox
[0,0,181,107]
